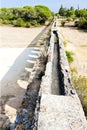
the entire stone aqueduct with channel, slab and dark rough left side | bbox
[11,20,87,130]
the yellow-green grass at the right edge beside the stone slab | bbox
[71,68,87,117]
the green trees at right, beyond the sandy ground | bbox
[58,5,87,29]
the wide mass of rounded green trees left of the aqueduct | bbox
[0,5,53,27]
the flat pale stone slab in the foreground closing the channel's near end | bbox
[38,94,87,130]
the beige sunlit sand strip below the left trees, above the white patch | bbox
[0,26,44,48]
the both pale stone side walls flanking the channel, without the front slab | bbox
[41,22,74,95]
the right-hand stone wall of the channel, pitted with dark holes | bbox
[57,31,75,95]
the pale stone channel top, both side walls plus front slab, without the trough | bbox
[38,21,87,130]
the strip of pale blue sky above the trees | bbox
[0,0,87,12]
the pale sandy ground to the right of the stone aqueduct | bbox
[58,20,87,77]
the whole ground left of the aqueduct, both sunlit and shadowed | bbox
[0,26,44,122]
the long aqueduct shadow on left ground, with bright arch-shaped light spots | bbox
[0,28,46,127]
